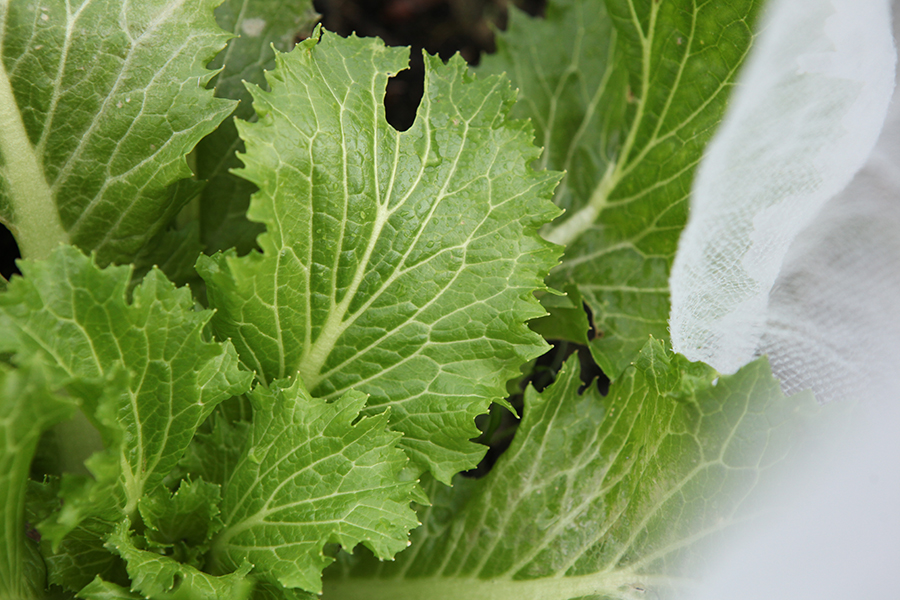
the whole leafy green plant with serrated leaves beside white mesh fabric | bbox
[0,0,814,599]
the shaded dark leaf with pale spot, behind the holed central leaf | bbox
[196,0,318,254]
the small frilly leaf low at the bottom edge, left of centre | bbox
[107,519,253,600]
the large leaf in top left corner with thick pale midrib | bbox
[0,0,233,264]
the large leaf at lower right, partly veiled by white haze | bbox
[325,340,817,600]
